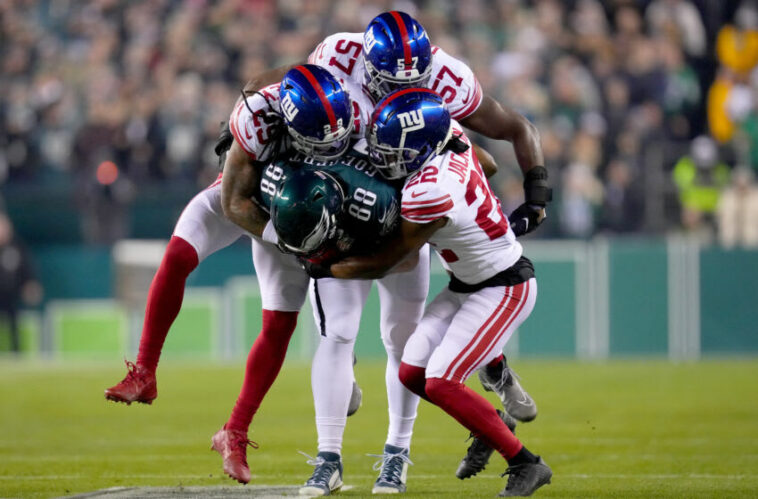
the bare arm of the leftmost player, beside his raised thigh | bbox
[221,141,269,236]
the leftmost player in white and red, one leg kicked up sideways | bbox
[105,65,365,483]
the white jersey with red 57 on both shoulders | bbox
[308,33,482,120]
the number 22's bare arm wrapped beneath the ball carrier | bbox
[329,217,447,279]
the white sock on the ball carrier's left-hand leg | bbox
[311,337,355,454]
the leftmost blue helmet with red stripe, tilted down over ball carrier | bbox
[279,64,353,161]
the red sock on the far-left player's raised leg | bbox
[137,236,199,371]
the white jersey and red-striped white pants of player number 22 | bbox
[401,126,537,382]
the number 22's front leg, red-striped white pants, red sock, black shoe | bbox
[425,278,552,495]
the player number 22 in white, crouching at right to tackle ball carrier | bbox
[311,89,552,496]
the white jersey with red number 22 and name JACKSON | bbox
[401,122,522,284]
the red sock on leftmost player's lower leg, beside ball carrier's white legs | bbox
[226,310,297,432]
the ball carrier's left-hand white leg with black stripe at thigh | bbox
[300,279,372,495]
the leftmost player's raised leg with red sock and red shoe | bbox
[105,179,245,404]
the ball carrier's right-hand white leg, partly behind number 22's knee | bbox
[372,247,429,494]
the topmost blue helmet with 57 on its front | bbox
[363,10,432,100]
